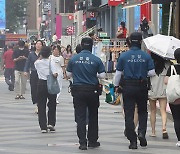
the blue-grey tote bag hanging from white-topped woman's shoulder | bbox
[47,59,60,94]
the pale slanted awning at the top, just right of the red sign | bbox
[123,0,152,9]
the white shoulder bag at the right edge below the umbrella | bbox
[166,65,180,104]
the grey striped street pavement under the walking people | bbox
[0,77,180,154]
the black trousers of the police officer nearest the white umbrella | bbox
[123,83,148,142]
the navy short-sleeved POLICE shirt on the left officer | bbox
[67,50,105,85]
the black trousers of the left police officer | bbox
[73,89,99,144]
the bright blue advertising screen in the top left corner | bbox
[0,0,6,30]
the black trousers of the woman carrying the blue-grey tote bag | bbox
[37,80,57,130]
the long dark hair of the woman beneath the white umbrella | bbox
[151,52,167,76]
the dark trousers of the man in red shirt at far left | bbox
[4,68,15,88]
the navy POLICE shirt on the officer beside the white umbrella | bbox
[116,47,154,80]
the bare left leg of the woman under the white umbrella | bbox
[149,100,156,137]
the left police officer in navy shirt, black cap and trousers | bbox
[67,37,105,150]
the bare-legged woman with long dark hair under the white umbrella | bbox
[148,53,171,139]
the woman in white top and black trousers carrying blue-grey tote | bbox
[34,46,58,133]
